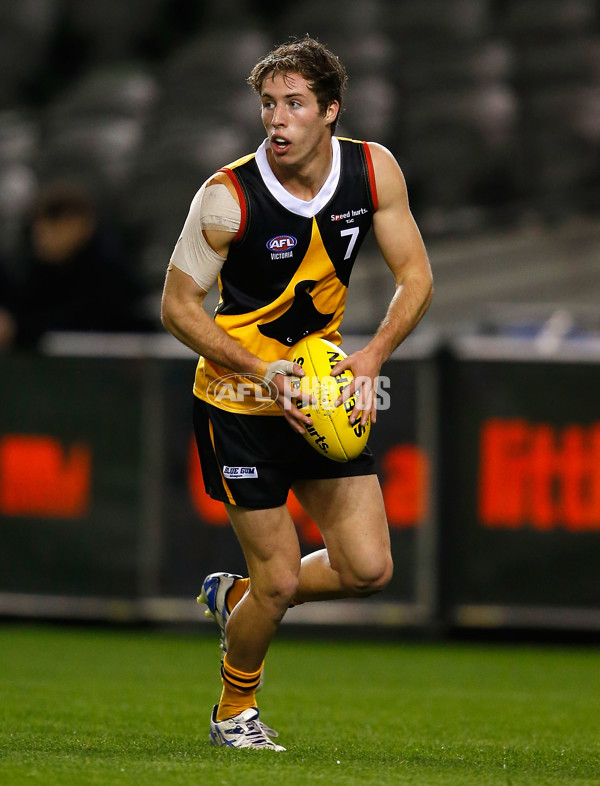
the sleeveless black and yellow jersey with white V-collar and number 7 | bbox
[194,137,377,414]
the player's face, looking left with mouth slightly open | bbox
[261,74,339,167]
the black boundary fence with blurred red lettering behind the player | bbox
[0,331,600,631]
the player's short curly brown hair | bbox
[248,35,348,134]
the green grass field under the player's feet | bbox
[0,626,600,786]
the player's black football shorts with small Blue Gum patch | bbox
[194,396,375,510]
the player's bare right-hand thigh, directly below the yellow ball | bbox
[293,475,391,573]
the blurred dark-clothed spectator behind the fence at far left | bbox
[0,182,153,347]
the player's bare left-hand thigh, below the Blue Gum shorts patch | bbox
[225,505,301,589]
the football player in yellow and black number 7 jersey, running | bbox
[162,37,432,750]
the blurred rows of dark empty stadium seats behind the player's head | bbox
[0,0,600,324]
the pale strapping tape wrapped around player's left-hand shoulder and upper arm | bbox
[171,183,241,292]
